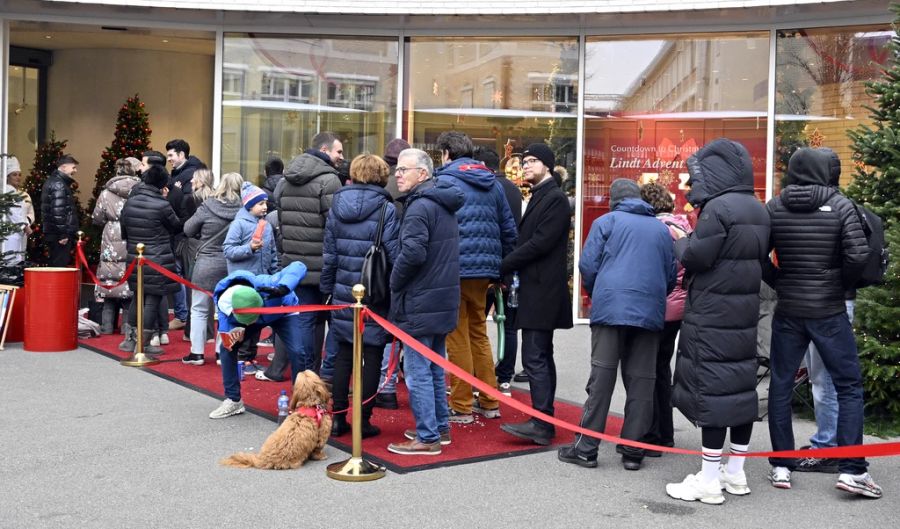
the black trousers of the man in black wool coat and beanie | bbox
[522,329,556,434]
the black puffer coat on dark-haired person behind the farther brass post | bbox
[120,183,181,296]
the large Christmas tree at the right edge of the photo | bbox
[847,4,900,417]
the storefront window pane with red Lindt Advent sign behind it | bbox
[578,33,769,318]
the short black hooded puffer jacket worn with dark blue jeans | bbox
[766,148,869,318]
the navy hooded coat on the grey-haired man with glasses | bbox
[391,178,463,336]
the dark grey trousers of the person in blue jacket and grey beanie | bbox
[575,325,660,457]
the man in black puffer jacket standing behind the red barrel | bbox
[41,154,79,266]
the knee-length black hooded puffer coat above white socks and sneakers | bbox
[672,139,769,428]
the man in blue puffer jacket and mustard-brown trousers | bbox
[435,131,516,424]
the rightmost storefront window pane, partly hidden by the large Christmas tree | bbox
[774,25,894,191]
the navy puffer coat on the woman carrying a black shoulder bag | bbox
[320,184,400,345]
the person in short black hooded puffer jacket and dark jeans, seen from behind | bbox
[766,148,882,498]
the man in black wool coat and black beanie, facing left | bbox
[500,143,572,446]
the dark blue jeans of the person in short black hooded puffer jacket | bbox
[769,313,868,474]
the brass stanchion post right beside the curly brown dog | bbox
[326,285,385,481]
